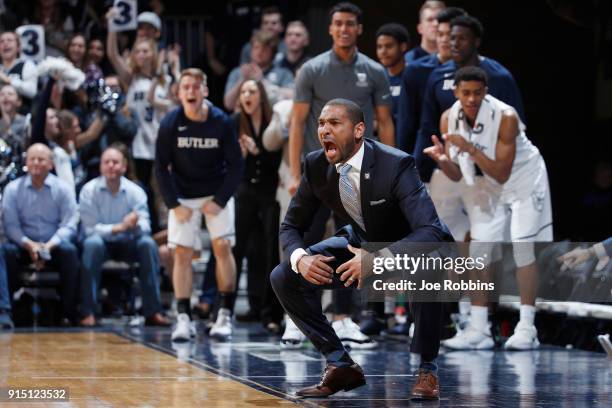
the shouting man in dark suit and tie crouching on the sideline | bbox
[270,99,452,399]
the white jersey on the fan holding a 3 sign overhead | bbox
[126,75,169,160]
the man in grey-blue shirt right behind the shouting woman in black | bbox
[223,30,293,111]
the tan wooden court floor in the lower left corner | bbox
[0,332,292,407]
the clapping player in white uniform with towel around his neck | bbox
[425,67,552,350]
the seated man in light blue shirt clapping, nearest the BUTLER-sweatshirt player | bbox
[79,145,170,326]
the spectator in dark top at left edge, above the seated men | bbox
[0,85,30,191]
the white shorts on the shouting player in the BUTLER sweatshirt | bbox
[168,196,236,251]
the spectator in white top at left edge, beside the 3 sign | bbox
[0,31,38,114]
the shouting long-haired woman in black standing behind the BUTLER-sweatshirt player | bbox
[234,80,283,333]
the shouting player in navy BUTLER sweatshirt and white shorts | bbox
[155,68,244,341]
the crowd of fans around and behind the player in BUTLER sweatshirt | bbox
[0,1,309,331]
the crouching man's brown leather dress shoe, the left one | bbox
[296,364,365,398]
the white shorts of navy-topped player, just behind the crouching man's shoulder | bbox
[427,169,470,242]
